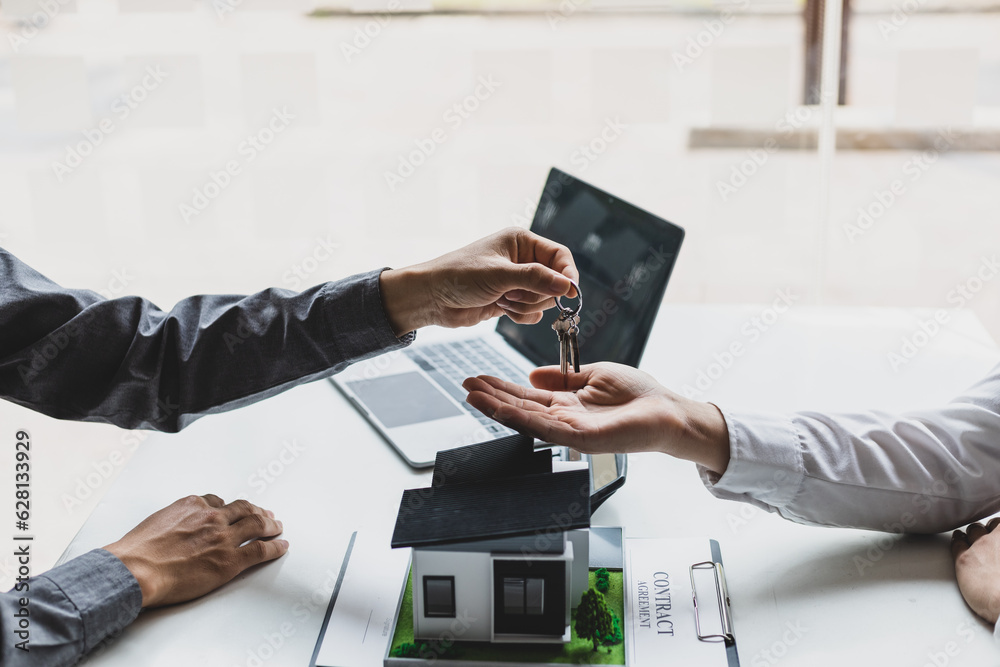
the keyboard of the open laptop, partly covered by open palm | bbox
[406,338,529,438]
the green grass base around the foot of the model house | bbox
[392,570,625,665]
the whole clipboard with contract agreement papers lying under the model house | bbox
[310,533,740,667]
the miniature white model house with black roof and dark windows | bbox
[392,435,590,643]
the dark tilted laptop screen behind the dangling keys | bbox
[497,169,684,366]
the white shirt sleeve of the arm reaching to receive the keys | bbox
[700,365,1000,533]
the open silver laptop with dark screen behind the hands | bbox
[331,169,684,468]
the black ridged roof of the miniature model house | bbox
[392,436,590,548]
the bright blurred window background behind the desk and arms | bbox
[0,0,1000,338]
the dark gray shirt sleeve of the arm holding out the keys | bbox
[0,249,414,432]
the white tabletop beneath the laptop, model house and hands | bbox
[56,305,1000,667]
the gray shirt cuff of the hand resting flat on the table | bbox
[0,549,142,667]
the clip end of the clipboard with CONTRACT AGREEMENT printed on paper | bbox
[625,538,740,667]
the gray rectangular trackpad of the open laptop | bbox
[344,372,465,428]
